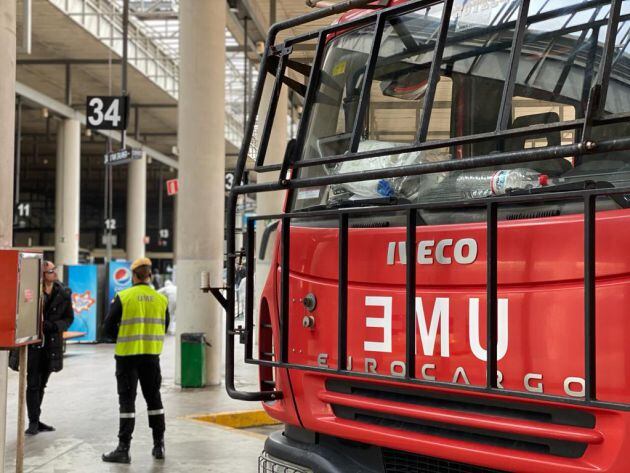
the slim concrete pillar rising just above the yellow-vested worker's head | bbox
[127,153,147,261]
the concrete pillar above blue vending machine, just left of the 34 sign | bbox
[55,118,81,266]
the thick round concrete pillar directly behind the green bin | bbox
[175,0,225,385]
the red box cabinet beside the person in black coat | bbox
[0,249,43,349]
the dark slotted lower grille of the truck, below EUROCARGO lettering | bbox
[326,379,595,460]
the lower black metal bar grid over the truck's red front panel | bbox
[237,181,630,410]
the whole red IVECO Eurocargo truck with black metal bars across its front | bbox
[220,0,630,473]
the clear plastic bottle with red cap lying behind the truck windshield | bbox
[455,168,548,199]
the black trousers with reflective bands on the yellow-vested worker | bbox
[116,355,166,444]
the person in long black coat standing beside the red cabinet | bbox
[26,261,74,435]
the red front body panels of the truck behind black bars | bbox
[261,210,630,472]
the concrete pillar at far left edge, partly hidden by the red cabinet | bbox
[0,0,16,473]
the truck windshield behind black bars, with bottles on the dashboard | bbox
[293,0,630,218]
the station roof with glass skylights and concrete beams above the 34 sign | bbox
[17,0,328,168]
